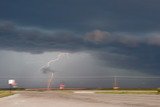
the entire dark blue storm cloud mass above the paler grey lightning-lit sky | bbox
[0,0,160,74]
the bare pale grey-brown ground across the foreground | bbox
[0,91,160,107]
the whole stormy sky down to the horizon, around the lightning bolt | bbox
[0,0,160,88]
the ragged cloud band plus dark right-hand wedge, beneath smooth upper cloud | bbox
[0,21,160,74]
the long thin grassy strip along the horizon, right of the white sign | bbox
[23,89,160,95]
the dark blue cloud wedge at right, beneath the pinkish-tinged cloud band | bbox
[94,45,160,75]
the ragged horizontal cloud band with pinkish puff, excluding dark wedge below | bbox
[0,21,160,53]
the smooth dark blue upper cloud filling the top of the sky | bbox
[0,0,160,32]
